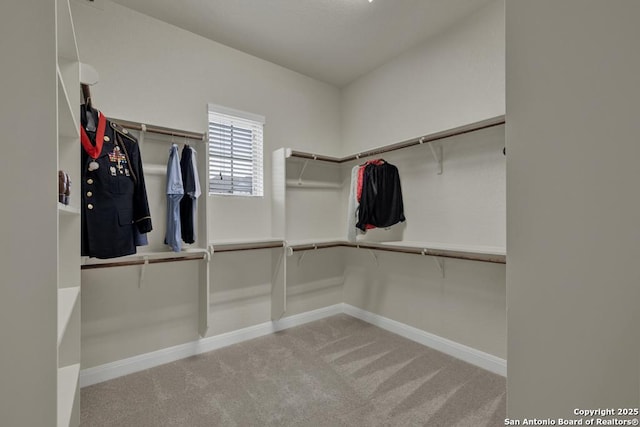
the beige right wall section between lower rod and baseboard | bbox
[344,249,507,359]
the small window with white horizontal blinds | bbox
[209,104,264,196]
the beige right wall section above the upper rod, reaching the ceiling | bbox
[342,0,505,154]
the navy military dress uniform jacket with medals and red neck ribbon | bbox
[80,106,152,258]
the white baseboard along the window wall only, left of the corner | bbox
[80,304,343,387]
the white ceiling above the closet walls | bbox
[114,0,490,86]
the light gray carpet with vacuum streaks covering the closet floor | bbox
[81,315,506,427]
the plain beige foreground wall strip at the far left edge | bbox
[0,0,58,427]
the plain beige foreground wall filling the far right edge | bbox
[506,0,640,418]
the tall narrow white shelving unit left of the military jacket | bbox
[56,0,81,427]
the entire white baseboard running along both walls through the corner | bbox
[80,303,507,387]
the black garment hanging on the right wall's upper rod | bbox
[356,162,405,231]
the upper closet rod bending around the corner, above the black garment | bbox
[290,116,506,163]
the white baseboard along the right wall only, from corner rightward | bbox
[343,304,507,377]
